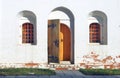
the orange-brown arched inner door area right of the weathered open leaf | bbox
[59,23,71,61]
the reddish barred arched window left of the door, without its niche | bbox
[22,23,34,44]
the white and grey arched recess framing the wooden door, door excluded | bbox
[48,6,74,63]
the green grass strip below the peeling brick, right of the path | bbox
[79,69,120,75]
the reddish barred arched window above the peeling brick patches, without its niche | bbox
[89,23,101,43]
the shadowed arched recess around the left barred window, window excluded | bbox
[18,10,37,45]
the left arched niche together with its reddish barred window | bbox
[18,10,37,45]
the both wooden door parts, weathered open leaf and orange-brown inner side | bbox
[48,20,71,63]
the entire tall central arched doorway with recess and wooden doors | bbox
[48,7,74,64]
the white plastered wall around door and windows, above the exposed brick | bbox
[0,0,120,67]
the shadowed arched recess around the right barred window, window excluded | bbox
[88,10,108,45]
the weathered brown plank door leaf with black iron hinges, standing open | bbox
[48,20,60,63]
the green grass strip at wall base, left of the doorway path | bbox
[0,68,55,76]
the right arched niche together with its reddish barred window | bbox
[88,11,108,45]
